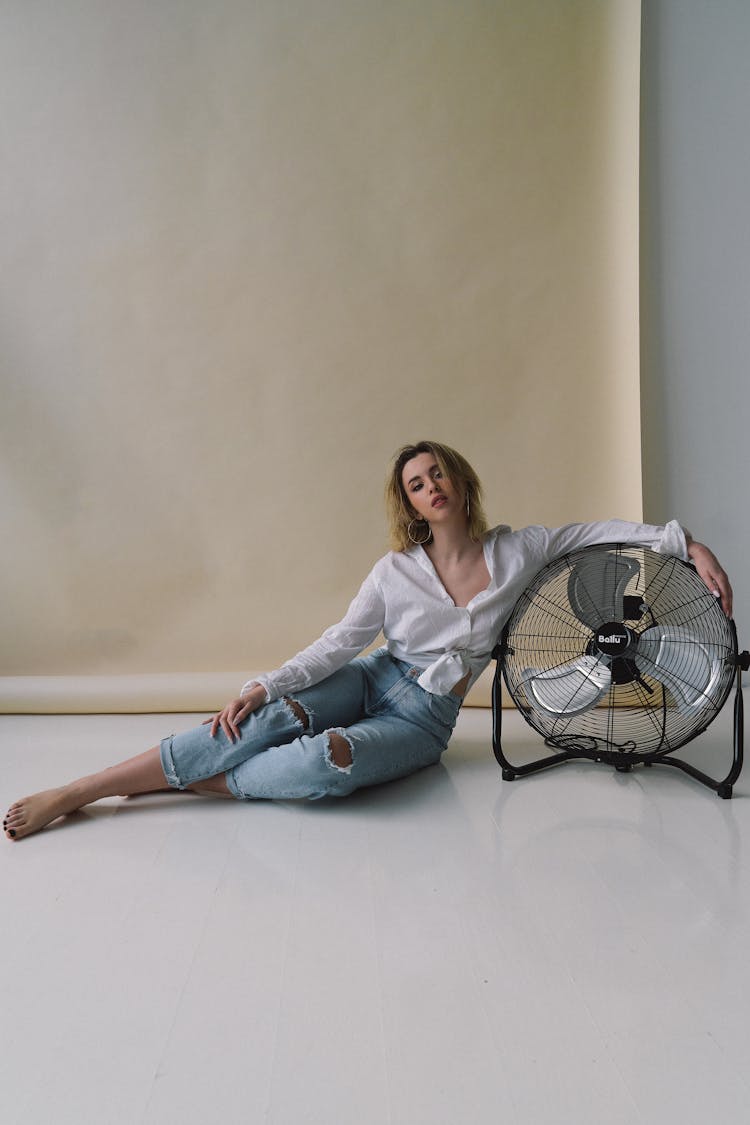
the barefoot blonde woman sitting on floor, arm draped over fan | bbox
[3,441,732,840]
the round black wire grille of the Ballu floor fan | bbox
[503,543,737,755]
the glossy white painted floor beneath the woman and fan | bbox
[0,705,750,1125]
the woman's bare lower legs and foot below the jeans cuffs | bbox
[2,746,232,839]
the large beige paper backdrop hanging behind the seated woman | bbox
[0,0,641,710]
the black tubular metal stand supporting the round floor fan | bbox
[493,621,750,800]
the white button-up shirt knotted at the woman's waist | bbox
[243,520,687,701]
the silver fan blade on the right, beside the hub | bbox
[635,626,723,716]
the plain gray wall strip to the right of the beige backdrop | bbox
[641,0,750,647]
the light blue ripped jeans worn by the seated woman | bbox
[161,649,461,800]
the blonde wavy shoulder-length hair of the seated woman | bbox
[386,441,487,551]
